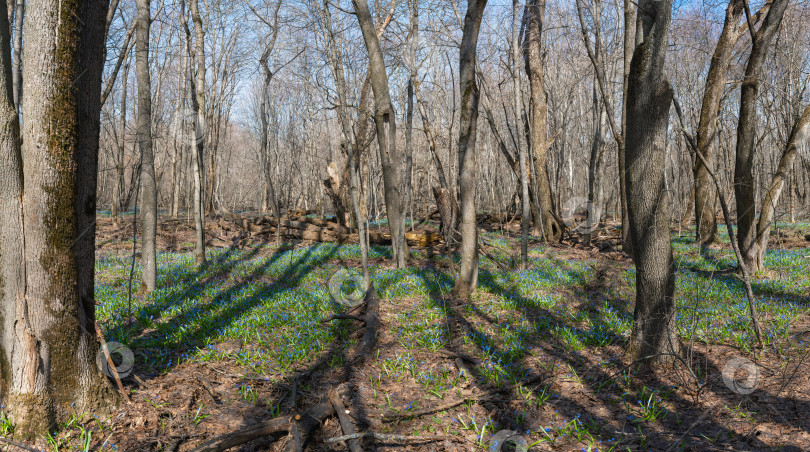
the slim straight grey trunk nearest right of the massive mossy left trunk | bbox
[135,0,157,293]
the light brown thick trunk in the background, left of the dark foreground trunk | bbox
[525,0,562,242]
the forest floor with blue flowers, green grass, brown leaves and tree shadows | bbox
[25,217,810,451]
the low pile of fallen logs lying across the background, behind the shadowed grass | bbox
[217,211,444,247]
